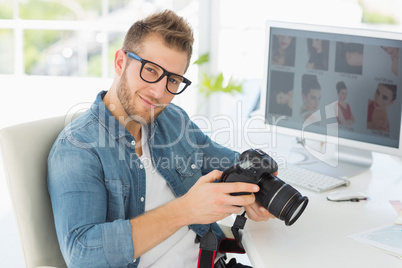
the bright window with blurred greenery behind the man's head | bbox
[0,0,197,77]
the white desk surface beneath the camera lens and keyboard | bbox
[236,139,402,268]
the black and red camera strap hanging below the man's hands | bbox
[197,212,247,268]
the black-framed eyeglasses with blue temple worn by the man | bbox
[124,50,191,95]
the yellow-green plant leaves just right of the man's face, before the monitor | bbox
[194,53,243,98]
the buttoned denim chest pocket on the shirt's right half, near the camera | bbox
[176,148,203,190]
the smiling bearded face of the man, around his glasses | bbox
[117,34,187,124]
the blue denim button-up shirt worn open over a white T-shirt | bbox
[48,92,238,268]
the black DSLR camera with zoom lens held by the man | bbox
[220,149,308,225]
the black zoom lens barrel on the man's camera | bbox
[255,174,308,225]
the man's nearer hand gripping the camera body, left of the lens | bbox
[181,170,259,224]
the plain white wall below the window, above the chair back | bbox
[0,76,111,129]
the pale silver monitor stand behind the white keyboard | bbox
[288,140,373,179]
